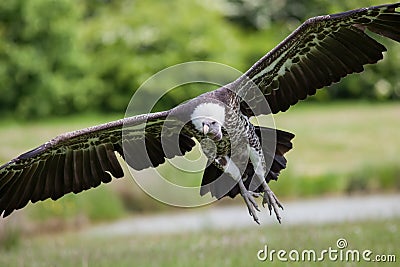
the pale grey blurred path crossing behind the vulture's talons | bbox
[83,194,400,236]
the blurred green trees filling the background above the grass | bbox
[0,0,400,118]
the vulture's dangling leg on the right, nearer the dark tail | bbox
[250,148,283,223]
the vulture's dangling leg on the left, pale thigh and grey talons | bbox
[215,156,261,224]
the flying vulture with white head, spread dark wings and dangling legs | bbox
[0,3,400,223]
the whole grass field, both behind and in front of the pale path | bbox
[0,103,400,267]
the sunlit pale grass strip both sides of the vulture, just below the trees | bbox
[0,102,400,180]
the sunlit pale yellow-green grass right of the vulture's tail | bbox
[275,102,400,177]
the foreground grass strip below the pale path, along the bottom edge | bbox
[0,219,400,267]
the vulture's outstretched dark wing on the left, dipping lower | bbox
[0,111,195,217]
